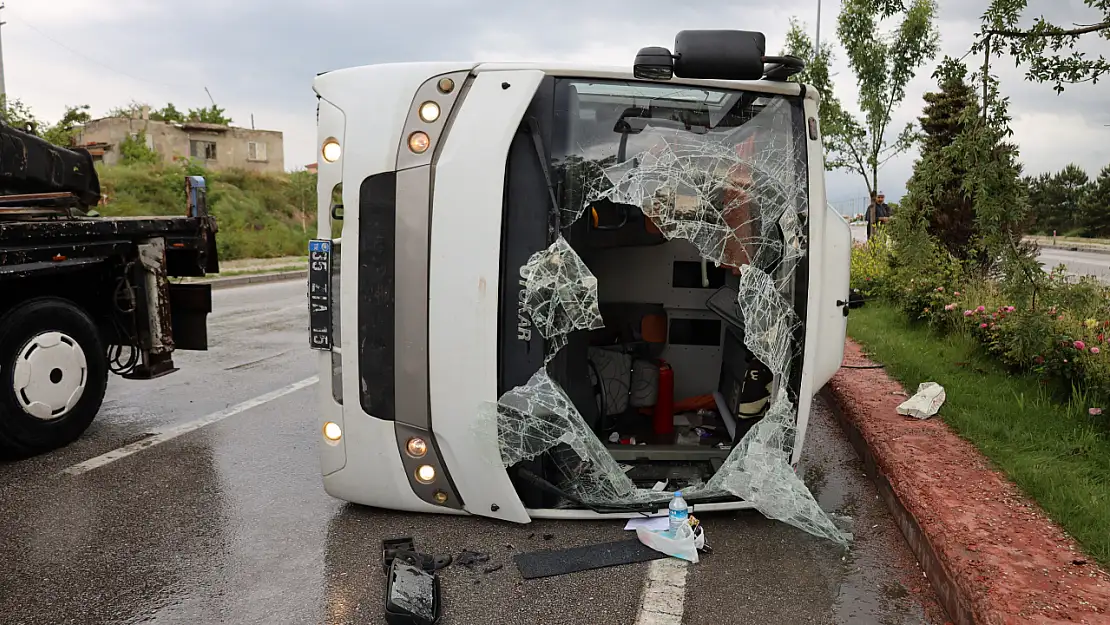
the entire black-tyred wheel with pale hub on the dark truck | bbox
[0,298,109,460]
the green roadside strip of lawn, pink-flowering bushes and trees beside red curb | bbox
[840,0,1110,564]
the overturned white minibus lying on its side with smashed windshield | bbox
[309,31,851,533]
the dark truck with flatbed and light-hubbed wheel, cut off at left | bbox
[0,124,220,460]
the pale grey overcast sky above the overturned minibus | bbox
[0,0,1110,209]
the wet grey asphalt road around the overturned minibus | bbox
[0,281,945,625]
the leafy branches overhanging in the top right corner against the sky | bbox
[972,0,1110,93]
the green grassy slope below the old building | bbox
[97,163,316,260]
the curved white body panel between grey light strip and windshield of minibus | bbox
[428,70,544,523]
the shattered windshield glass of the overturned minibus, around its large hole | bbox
[478,79,849,543]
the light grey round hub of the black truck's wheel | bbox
[12,332,89,420]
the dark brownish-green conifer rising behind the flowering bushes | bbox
[897,67,983,264]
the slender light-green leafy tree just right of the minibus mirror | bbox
[828,0,939,194]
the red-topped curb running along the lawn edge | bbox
[826,340,1110,625]
